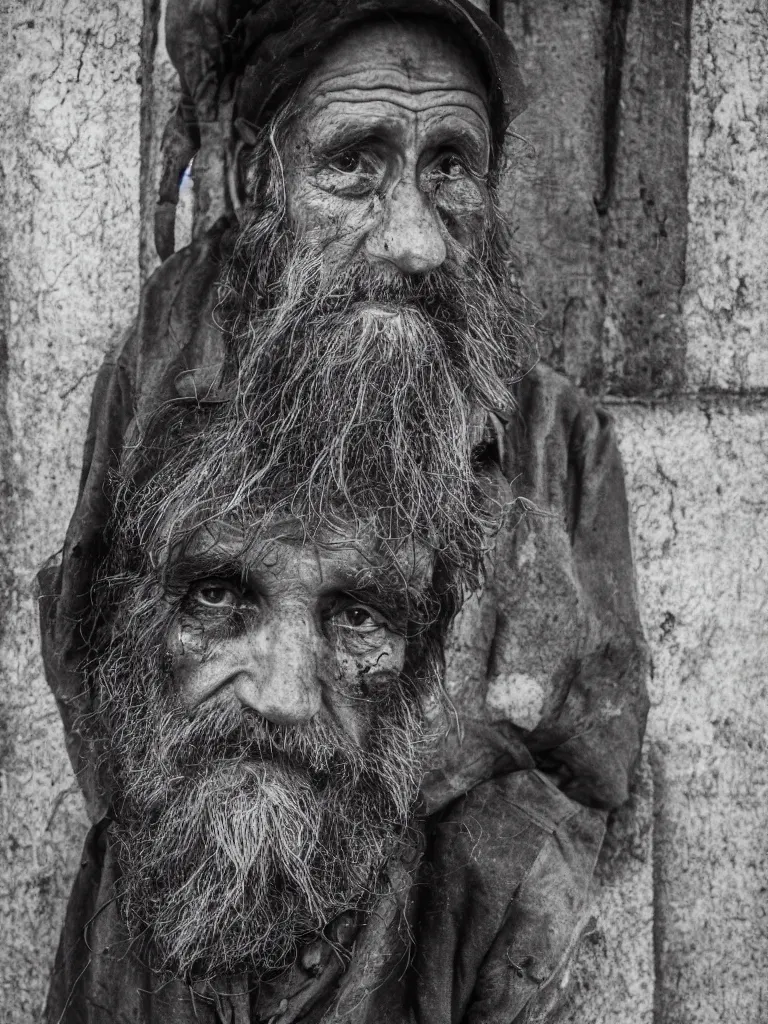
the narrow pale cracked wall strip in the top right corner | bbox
[685,0,768,390]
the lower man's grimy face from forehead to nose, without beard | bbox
[167,524,429,749]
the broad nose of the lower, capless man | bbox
[232,618,323,725]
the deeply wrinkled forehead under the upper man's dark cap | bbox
[298,18,489,125]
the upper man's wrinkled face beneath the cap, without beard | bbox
[285,22,490,274]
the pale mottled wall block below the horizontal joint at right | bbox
[617,401,768,1024]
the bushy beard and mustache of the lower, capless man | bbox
[96,598,436,981]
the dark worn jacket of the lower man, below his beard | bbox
[46,771,603,1024]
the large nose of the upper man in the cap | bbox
[366,180,446,273]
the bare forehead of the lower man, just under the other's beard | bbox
[176,519,434,590]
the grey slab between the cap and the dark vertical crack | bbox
[502,0,607,380]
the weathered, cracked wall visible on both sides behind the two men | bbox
[0,0,768,1024]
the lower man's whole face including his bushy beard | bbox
[97,520,437,980]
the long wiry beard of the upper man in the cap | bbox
[148,186,531,587]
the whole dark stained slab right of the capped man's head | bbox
[502,0,688,395]
